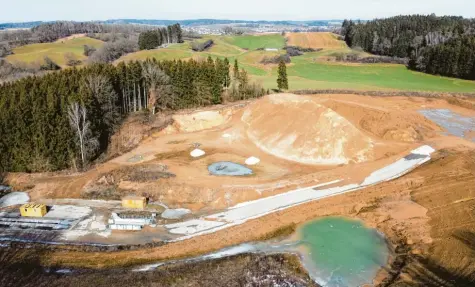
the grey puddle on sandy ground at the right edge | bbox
[419,109,475,142]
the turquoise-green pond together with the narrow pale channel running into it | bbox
[134,217,389,287]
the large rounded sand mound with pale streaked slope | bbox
[241,94,374,165]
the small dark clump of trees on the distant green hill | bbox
[139,24,183,50]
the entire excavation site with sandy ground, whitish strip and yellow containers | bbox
[0,94,475,286]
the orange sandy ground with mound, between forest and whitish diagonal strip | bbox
[8,95,447,211]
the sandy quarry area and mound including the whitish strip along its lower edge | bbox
[3,94,475,248]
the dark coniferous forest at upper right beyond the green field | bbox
[342,15,475,80]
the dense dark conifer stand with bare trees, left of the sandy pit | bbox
[0,58,266,172]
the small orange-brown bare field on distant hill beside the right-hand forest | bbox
[285,32,346,49]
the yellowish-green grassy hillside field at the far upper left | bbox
[7,37,104,67]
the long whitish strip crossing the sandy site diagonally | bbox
[165,146,434,239]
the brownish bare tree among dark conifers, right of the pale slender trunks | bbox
[142,62,174,114]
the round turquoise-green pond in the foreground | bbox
[299,217,389,287]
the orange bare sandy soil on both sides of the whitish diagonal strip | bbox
[3,95,475,280]
